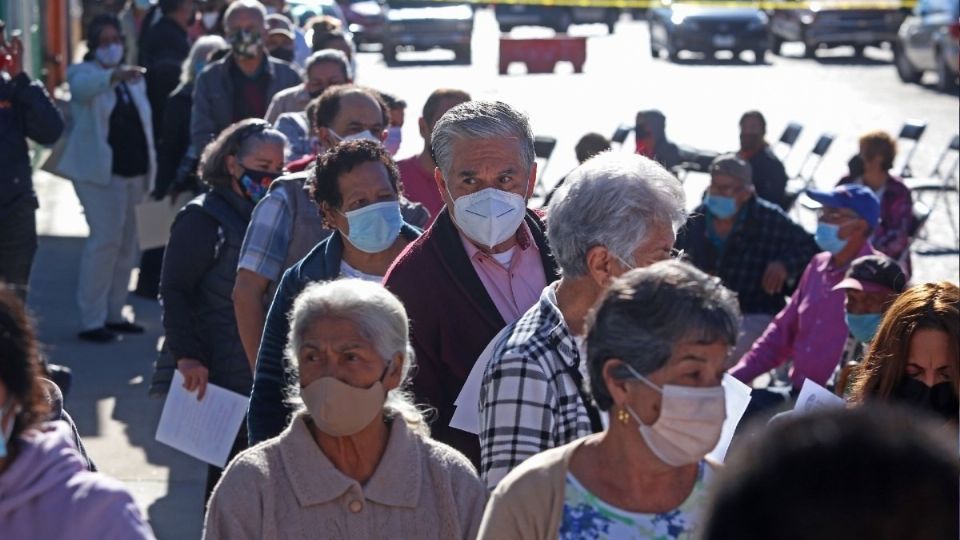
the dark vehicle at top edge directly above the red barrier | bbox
[493,3,620,34]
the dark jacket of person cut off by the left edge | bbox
[0,72,63,214]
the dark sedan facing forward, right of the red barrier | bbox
[647,1,768,64]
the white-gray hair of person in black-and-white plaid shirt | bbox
[547,152,686,278]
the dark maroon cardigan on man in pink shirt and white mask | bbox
[383,209,559,468]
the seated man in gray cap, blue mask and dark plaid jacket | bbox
[677,154,819,363]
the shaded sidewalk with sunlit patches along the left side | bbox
[28,172,206,540]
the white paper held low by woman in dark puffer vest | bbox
[156,371,247,467]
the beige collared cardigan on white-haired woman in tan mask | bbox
[203,413,486,540]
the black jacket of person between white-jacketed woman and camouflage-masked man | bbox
[140,17,190,145]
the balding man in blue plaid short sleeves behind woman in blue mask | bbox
[233,85,429,369]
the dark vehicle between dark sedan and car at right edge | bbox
[770,0,904,58]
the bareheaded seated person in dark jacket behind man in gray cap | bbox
[737,111,789,210]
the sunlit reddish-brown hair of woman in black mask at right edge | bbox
[851,281,960,403]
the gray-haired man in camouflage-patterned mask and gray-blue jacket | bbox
[190,0,302,156]
